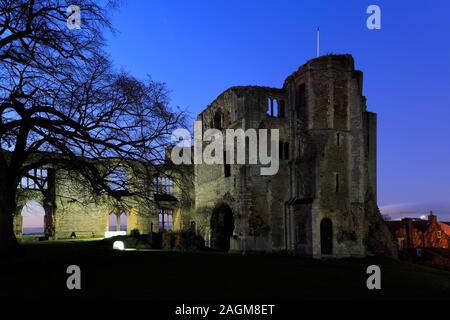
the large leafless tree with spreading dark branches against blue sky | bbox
[0,0,184,250]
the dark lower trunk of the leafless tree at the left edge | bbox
[0,190,19,253]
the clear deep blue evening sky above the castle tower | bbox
[102,0,450,218]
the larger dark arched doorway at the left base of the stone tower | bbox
[211,204,234,252]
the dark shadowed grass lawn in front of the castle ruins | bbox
[0,241,450,302]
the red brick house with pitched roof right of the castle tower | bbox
[386,212,450,251]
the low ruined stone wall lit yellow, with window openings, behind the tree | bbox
[14,159,194,239]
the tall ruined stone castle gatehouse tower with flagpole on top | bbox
[195,55,394,257]
